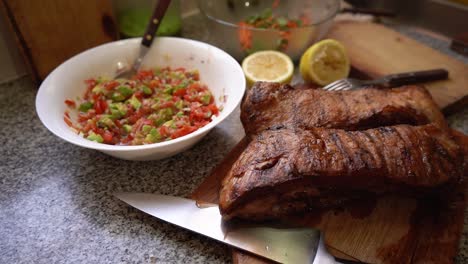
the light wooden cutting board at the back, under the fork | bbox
[328,21,468,113]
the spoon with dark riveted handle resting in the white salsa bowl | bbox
[115,0,171,79]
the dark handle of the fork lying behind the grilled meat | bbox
[384,69,449,87]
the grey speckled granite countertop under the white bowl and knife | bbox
[0,13,468,263]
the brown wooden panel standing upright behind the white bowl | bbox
[0,0,118,81]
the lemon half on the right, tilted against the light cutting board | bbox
[299,39,350,85]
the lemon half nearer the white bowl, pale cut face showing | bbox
[242,50,294,85]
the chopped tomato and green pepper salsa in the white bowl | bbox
[64,67,220,145]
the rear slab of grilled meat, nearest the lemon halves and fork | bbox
[241,82,447,135]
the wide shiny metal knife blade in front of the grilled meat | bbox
[115,193,336,264]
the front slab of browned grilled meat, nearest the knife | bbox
[220,124,463,220]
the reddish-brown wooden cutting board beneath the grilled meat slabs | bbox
[192,131,468,264]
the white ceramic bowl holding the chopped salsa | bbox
[36,37,245,160]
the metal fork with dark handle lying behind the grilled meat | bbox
[323,69,448,91]
